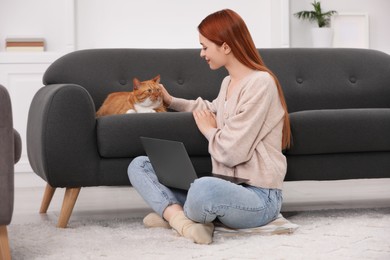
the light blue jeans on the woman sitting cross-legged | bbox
[128,156,282,228]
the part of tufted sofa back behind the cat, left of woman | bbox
[43,49,227,109]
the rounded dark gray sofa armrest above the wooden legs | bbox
[27,84,99,187]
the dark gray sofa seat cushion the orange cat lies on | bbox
[96,112,209,158]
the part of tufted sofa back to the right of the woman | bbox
[261,48,390,112]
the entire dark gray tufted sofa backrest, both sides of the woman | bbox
[43,48,390,112]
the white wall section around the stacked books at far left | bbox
[0,0,74,52]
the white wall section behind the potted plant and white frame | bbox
[290,0,390,54]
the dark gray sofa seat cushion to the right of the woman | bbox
[286,108,390,155]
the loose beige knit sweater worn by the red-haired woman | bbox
[170,71,287,189]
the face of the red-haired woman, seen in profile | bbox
[199,34,226,70]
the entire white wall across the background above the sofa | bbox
[0,0,390,53]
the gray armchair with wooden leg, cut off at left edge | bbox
[0,85,22,260]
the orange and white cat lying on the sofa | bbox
[96,75,167,117]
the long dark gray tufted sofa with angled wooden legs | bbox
[27,48,390,227]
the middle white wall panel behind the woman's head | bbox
[76,0,288,49]
